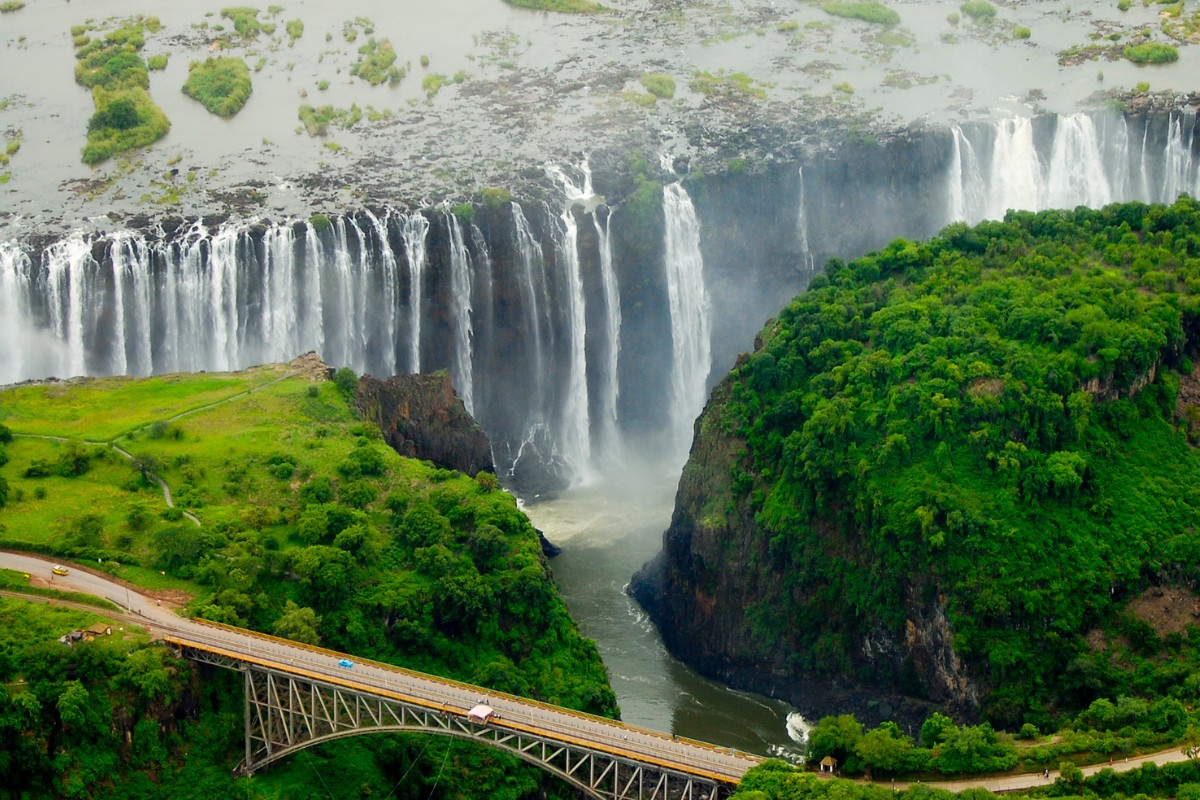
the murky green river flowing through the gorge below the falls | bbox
[524,460,804,760]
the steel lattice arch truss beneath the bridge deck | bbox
[181,646,734,800]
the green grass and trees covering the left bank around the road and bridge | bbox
[0,365,617,799]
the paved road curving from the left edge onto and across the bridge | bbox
[0,553,762,782]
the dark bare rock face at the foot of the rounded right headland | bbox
[629,371,950,726]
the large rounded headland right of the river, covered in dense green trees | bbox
[634,198,1200,729]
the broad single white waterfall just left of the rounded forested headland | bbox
[662,184,712,453]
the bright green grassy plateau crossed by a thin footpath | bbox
[0,365,436,602]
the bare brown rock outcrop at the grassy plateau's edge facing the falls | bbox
[354,372,496,475]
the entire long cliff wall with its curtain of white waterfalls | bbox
[0,110,1200,494]
